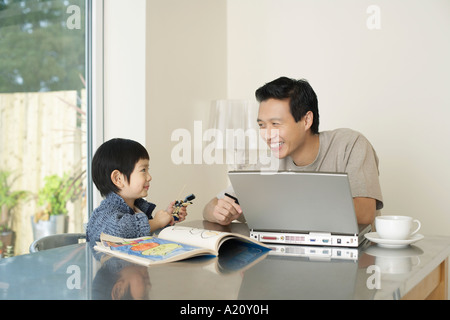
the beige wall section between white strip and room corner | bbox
[146,0,227,220]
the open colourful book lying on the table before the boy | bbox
[94,226,270,265]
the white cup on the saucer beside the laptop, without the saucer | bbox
[375,216,421,240]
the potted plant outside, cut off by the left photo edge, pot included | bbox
[0,170,30,258]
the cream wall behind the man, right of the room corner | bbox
[227,0,450,235]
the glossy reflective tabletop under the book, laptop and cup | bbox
[0,222,442,300]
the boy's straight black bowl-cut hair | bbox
[92,138,150,197]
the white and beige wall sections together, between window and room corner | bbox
[102,0,227,220]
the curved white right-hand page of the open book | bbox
[158,225,230,251]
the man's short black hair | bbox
[255,77,319,134]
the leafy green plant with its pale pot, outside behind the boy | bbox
[31,174,83,240]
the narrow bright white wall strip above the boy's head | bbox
[103,0,147,144]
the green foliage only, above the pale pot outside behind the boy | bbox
[35,174,84,221]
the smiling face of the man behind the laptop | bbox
[257,99,309,159]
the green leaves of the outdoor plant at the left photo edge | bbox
[0,170,30,232]
